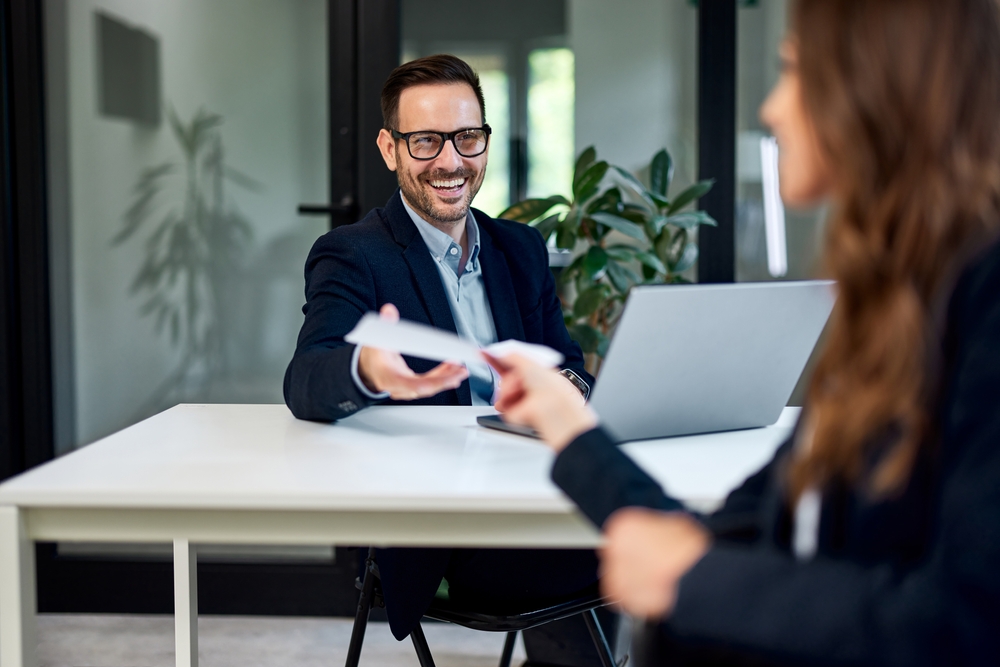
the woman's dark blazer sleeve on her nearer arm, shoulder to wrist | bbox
[664,253,1000,665]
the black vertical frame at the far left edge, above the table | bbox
[0,0,55,477]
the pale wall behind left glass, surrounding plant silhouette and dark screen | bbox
[53,0,328,444]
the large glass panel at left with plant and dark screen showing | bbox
[44,0,332,558]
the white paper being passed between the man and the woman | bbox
[344,313,563,367]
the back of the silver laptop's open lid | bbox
[590,281,835,441]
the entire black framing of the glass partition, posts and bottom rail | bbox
[0,0,736,616]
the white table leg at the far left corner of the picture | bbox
[0,507,37,667]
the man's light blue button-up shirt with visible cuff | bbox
[351,198,497,405]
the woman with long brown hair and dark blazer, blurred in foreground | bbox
[495,0,1000,665]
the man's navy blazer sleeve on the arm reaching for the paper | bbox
[284,232,376,421]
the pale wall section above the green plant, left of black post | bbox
[569,0,698,182]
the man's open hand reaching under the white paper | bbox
[358,303,469,401]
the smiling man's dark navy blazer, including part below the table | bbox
[284,191,593,639]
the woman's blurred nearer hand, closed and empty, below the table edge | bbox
[600,507,712,619]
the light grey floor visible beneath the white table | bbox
[38,614,525,667]
